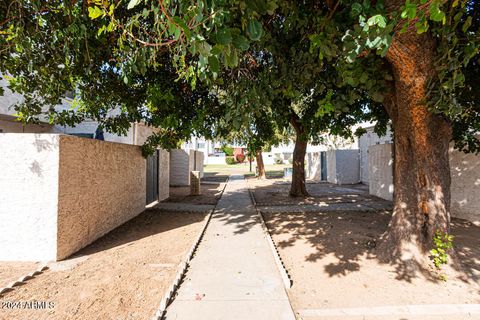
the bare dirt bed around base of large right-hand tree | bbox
[264,211,480,319]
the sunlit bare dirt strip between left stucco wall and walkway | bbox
[0,210,206,320]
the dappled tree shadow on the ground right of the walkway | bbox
[244,180,480,283]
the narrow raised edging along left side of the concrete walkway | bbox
[152,179,228,320]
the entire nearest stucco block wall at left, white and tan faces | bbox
[0,134,146,261]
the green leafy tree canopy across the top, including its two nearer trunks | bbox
[0,0,480,262]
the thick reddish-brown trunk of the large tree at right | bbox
[379,0,451,264]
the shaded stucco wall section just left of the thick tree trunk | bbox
[368,144,393,200]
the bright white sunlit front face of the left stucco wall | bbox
[0,133,59,261]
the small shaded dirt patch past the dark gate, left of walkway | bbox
[165,182,225,205]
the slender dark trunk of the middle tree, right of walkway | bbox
[290,117,308,197]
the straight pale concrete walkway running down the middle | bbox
[166,175,295,320]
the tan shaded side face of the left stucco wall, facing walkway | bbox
[57,135,146,259]
